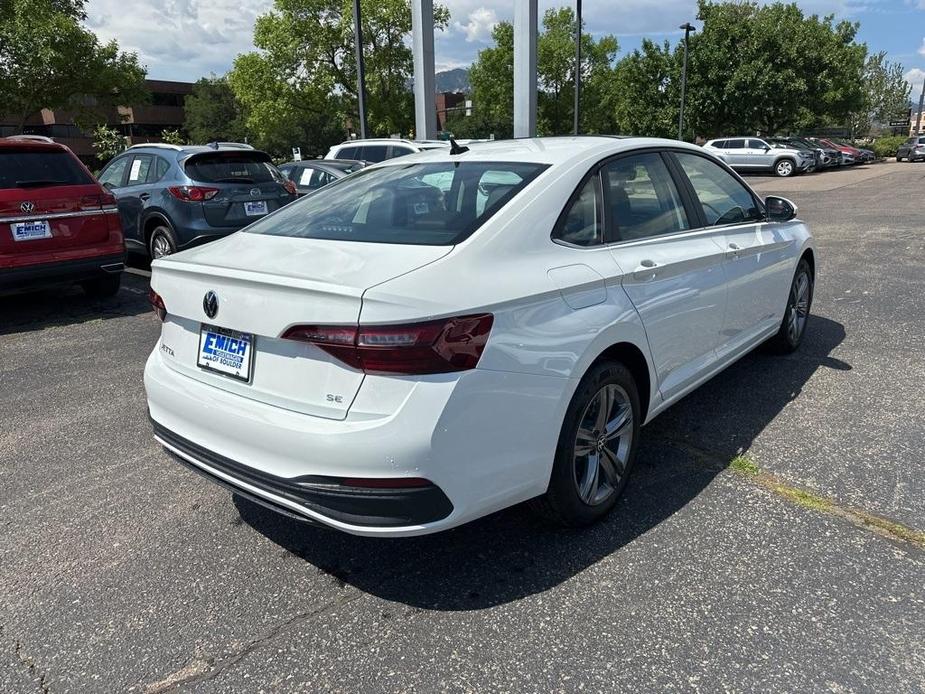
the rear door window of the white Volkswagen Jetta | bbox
[601,153,690,241]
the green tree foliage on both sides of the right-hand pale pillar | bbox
[466,7,618,137]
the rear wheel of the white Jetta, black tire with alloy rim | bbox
[533,361,641,527]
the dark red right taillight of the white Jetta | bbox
[282,313,494,374]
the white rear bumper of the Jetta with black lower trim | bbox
[144,343,574,537]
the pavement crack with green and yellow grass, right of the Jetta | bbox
[663,437,925,550]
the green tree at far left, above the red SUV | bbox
[0,0,147,132]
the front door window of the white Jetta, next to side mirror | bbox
[674,152,764,226]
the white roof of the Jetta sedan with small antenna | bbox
[364,135,703,167]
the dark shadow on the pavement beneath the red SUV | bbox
[0,273,151,335]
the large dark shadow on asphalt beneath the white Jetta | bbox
[234,316,851,617]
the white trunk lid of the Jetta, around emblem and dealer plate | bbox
[151,233,452,419]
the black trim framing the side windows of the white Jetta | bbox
[549,146,768,251]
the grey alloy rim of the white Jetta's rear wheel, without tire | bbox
[573,383,633,506]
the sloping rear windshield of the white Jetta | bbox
[247,162,547,246]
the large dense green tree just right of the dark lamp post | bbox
[688,0,867,136]
